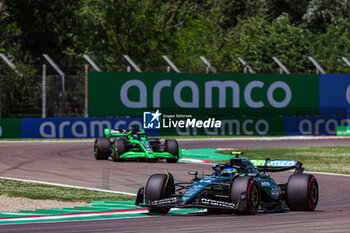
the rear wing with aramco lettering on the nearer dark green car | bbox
[250,158,304,172]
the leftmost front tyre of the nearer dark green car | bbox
[145,173,175,214]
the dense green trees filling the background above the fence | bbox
[0,0,350,74]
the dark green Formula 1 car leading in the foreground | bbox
[135,152,319,214]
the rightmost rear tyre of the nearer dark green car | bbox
[287,174,318,211]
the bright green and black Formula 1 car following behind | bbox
[94,129,181,163]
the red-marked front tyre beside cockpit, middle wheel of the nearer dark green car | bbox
[230,176,260,215]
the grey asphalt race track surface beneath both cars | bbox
[0,138,350,232]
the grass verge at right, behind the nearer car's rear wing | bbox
[219,146,350,174]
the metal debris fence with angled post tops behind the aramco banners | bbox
[0,53,350,118]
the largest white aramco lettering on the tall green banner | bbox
[120,79,293,109]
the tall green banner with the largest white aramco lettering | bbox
[89,72,319,117]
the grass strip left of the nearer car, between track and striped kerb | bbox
[0,179,135,202]
